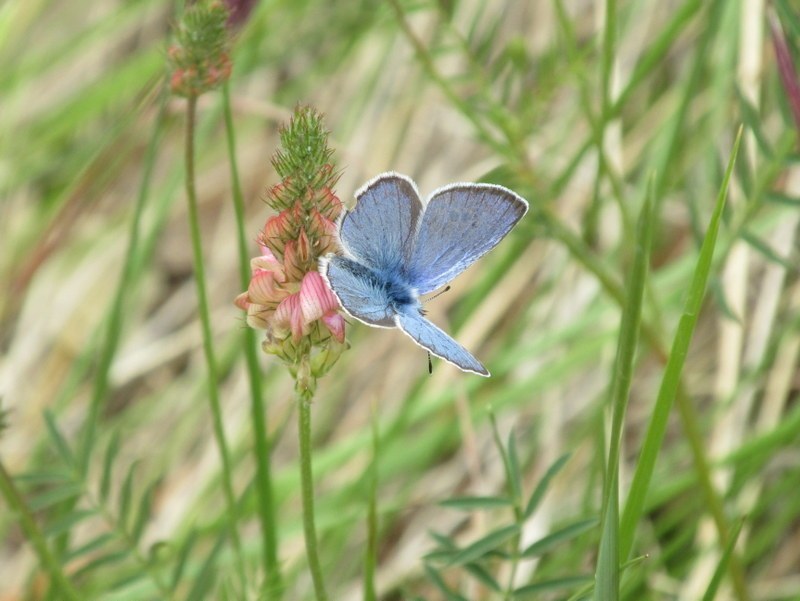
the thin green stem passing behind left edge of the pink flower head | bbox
[222,82,283,600]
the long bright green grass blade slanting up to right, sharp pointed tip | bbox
[619,127,742,560]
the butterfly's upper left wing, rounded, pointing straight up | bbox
[339,172,422,272]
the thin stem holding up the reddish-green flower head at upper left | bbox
[185,95,246,586]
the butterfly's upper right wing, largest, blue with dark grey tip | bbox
[406,184,528,294]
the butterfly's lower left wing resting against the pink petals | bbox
[319,255,395,328]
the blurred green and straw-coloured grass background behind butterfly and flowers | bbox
[0,0,800,601]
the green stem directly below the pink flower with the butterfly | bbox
[297,386,328,601]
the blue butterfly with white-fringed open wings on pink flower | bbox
[320,172,528,376]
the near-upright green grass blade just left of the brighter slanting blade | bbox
[594,179,655,600]
